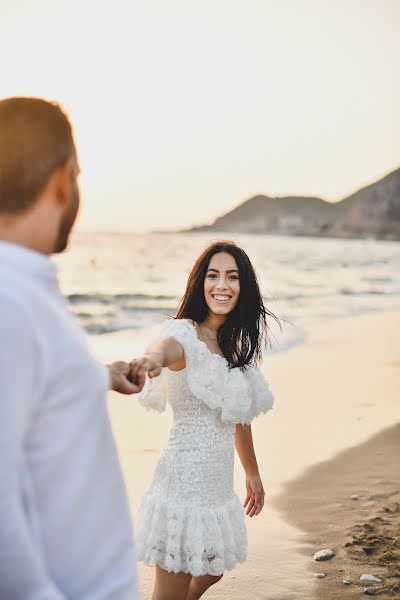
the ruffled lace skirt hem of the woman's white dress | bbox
[136,493,247,577]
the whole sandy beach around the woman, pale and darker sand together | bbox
[103,312,400,600]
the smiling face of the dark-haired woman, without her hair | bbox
[204,252,240,315]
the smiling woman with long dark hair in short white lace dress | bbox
[131,241,276,600]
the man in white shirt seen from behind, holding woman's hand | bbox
[0,98,144,600]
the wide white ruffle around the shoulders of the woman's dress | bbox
[139,319,273,424]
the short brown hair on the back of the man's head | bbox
[0,98,75,214]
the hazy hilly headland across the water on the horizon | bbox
[177,168,400,241]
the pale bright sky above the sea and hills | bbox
[0,0,400,231]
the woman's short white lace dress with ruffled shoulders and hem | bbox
[136,319,273,576]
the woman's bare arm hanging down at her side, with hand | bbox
[235,424,264,517]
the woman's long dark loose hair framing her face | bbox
[175,241,280,369]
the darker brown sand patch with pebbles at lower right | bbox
[275,422,400,600]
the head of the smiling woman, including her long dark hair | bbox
[177,241,278,368]
